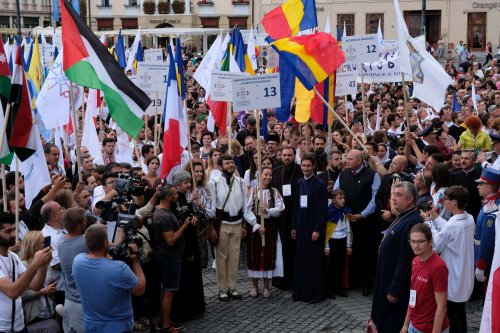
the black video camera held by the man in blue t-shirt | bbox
[108,214,144,264]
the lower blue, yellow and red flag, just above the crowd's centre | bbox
[268,32,345,90]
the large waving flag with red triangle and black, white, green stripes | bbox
[61,0,151,138]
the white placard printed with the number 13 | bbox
[233,73,281,112]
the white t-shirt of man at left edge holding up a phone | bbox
[0,251,26,332]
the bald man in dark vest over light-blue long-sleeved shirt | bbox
[333,149,380,296]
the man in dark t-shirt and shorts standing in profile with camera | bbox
[153,185,197,332]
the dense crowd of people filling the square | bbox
[0,39,500,333]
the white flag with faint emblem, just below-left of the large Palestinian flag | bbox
[35,51,71,128]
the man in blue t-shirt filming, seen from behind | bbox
[73,224,146,333]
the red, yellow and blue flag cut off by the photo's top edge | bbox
[262,0,318,39]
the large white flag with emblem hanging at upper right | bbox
[394,0,453,110]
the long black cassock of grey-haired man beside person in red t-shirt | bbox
[371,207,423,333]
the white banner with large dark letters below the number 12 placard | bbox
[343,49,412,83]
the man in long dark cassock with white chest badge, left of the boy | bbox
[292,154,328,303]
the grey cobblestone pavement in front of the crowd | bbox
[177,244,482,333]
